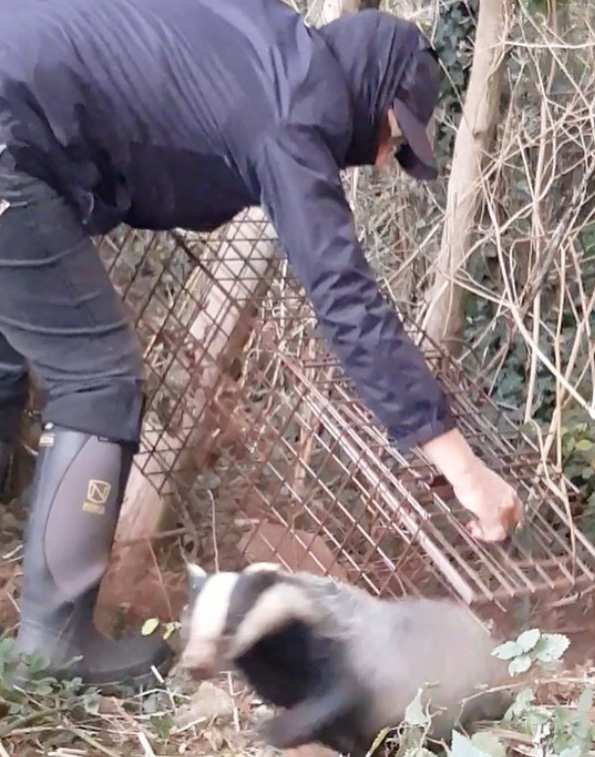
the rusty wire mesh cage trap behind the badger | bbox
[100,211,595,624]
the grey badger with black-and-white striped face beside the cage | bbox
[180,563,510,757]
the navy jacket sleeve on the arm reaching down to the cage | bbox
[257,129,455,452]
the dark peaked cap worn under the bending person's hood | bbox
[393,39,441,181]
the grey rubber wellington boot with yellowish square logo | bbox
[15,425,172,692]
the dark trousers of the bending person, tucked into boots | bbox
[0,153,143,443]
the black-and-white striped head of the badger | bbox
[180,563,316,680]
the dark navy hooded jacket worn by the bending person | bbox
[0,0,452,449]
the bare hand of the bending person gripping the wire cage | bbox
[423,429,523,542]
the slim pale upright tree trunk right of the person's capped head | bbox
[422,0,512,355]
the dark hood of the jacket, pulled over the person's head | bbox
[318,10,429,166]
